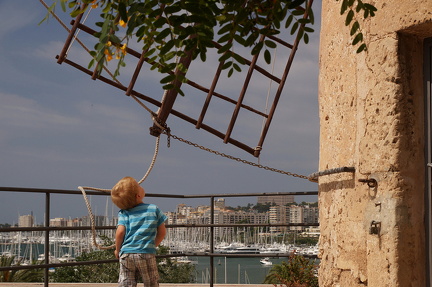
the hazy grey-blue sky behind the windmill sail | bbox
[0,0,321,223]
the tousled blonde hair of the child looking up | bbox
[111,176,140,209]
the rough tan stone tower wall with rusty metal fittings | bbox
[316,0,432,287]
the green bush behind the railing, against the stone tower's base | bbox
[264,254,318,287]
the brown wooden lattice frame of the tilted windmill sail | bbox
[57,0,313,157]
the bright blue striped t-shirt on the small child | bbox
[118,203,167,255]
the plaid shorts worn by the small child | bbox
[118,253,159,287]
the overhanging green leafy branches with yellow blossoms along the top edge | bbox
[44,0,376,93]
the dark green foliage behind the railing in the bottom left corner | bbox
[0,256,44,282]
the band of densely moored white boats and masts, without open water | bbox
[0,231,318,262]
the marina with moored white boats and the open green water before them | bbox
[0,231,319,284]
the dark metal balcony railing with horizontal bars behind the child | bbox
[0,187,319,287]
